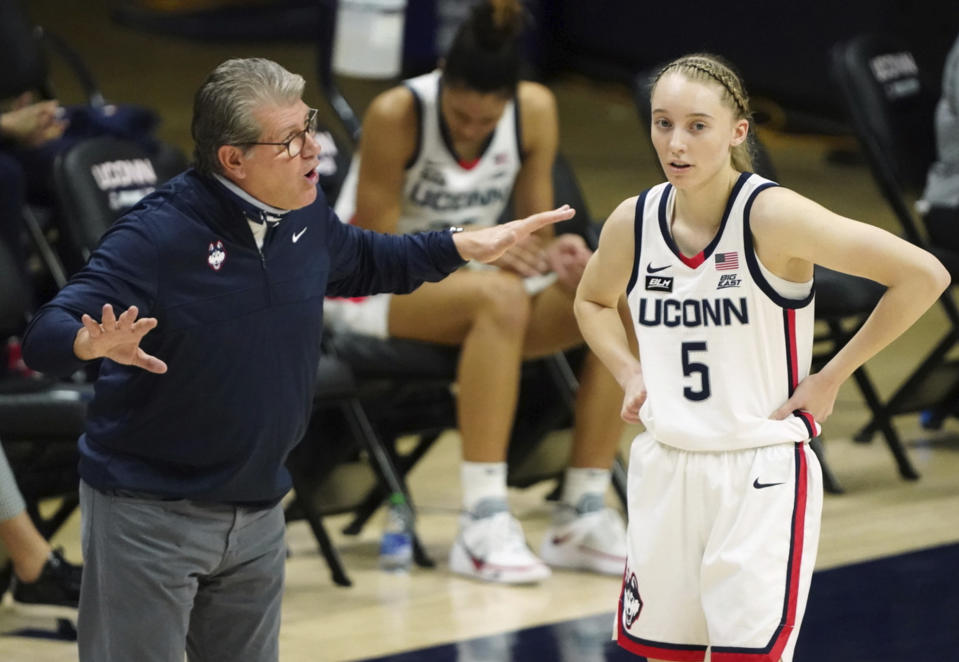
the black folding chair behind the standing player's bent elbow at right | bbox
[830,34,959,478]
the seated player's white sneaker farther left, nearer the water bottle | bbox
[450,499,551,584]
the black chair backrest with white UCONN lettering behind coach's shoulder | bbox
[53,136,184,270]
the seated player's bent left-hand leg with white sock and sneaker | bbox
[389,270,550,584]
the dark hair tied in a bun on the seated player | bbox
[443,0,526,97]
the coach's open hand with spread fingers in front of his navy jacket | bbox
[73,303,167,374]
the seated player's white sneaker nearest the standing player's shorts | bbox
[539,494,626,575]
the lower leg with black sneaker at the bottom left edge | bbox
[0,446,81,618]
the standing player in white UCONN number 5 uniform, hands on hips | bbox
[576,54,949,662]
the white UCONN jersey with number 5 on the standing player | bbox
[627,173,819,451]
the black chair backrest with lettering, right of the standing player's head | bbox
[830,34,937,243]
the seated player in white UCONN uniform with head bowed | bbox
[326,0,625,583]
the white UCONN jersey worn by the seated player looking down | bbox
[336,71,521,234]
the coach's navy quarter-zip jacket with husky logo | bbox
[24,170,463,504]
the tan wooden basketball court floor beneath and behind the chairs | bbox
[0,0,959,662]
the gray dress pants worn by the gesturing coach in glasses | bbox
[77,482,286,662]
